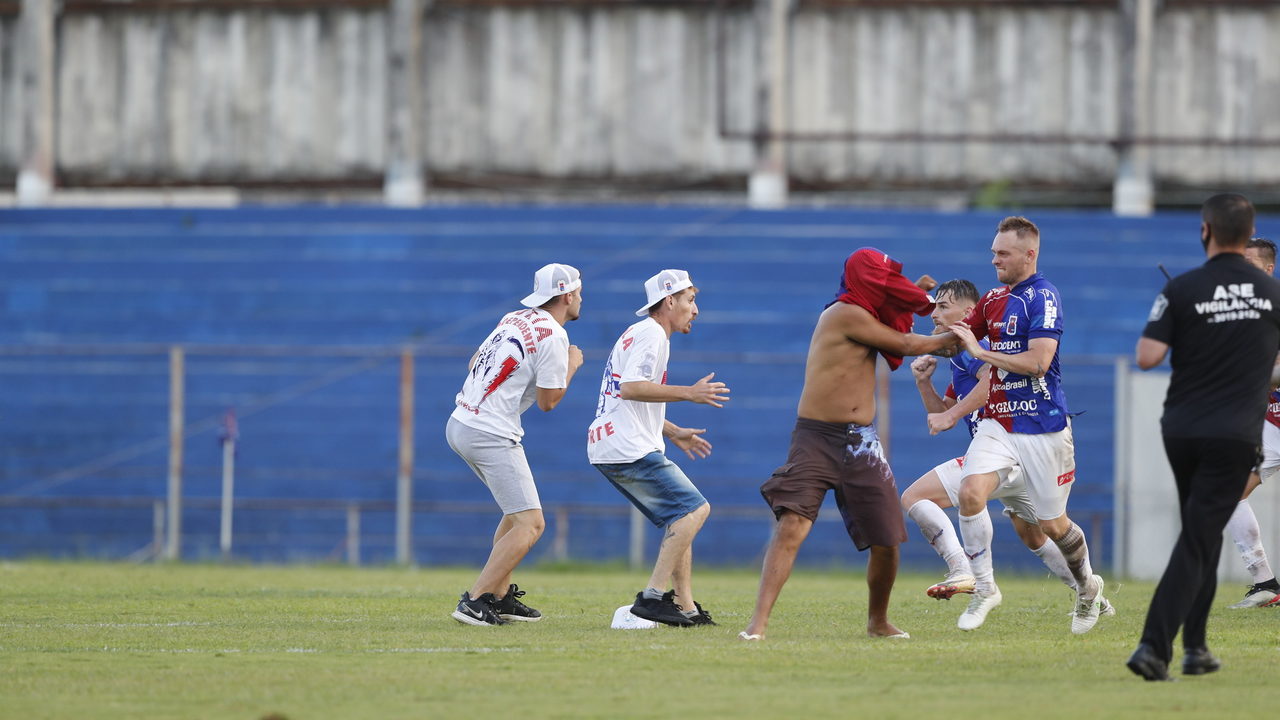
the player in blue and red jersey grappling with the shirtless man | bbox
[951,217,1103,634]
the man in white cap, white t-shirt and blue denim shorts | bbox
[586,270,730,626]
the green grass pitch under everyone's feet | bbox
[0,562,1280,720]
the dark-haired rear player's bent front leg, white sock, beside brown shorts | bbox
[902,459,974,600]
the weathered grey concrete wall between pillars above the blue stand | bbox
[0,3,1280,184]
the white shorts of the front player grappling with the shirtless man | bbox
[964,418,1075,520]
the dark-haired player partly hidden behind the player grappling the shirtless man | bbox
[902,274,1114,622]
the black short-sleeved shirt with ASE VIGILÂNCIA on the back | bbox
[1142,252,1280,442]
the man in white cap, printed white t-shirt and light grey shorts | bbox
[445,263,582,625]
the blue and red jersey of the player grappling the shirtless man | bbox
[964,273,1068,434]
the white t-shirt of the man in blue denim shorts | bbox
[586,318,671,464]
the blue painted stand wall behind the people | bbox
[0,206,1223,568]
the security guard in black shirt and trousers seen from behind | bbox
[1128,195,1280,680]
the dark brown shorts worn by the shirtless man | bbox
[760,418,906,550]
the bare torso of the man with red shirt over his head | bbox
[796,302,877,425]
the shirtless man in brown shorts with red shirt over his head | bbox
[739,247,956,641]
